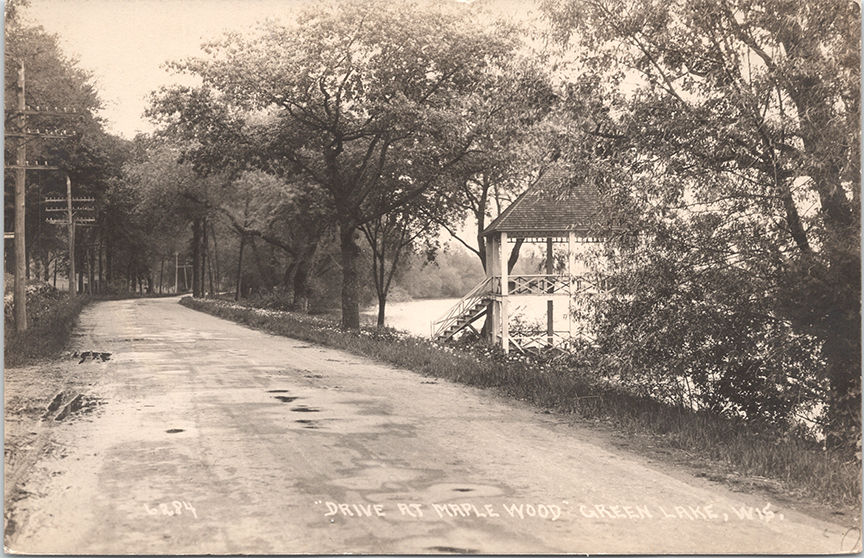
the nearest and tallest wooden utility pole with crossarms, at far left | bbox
[4,62,82,332]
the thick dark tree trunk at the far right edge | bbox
[781,34,861,451]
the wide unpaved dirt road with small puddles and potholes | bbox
[6,299,860,554]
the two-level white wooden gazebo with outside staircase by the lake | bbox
[432,167,600,352]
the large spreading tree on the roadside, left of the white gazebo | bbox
[178,1,528,329]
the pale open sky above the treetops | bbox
[24,0,530,139]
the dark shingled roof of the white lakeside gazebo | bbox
[483,166,600,237]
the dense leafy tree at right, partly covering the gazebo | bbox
[544,0,861,443]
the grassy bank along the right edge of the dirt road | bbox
[181,298,861,513]
